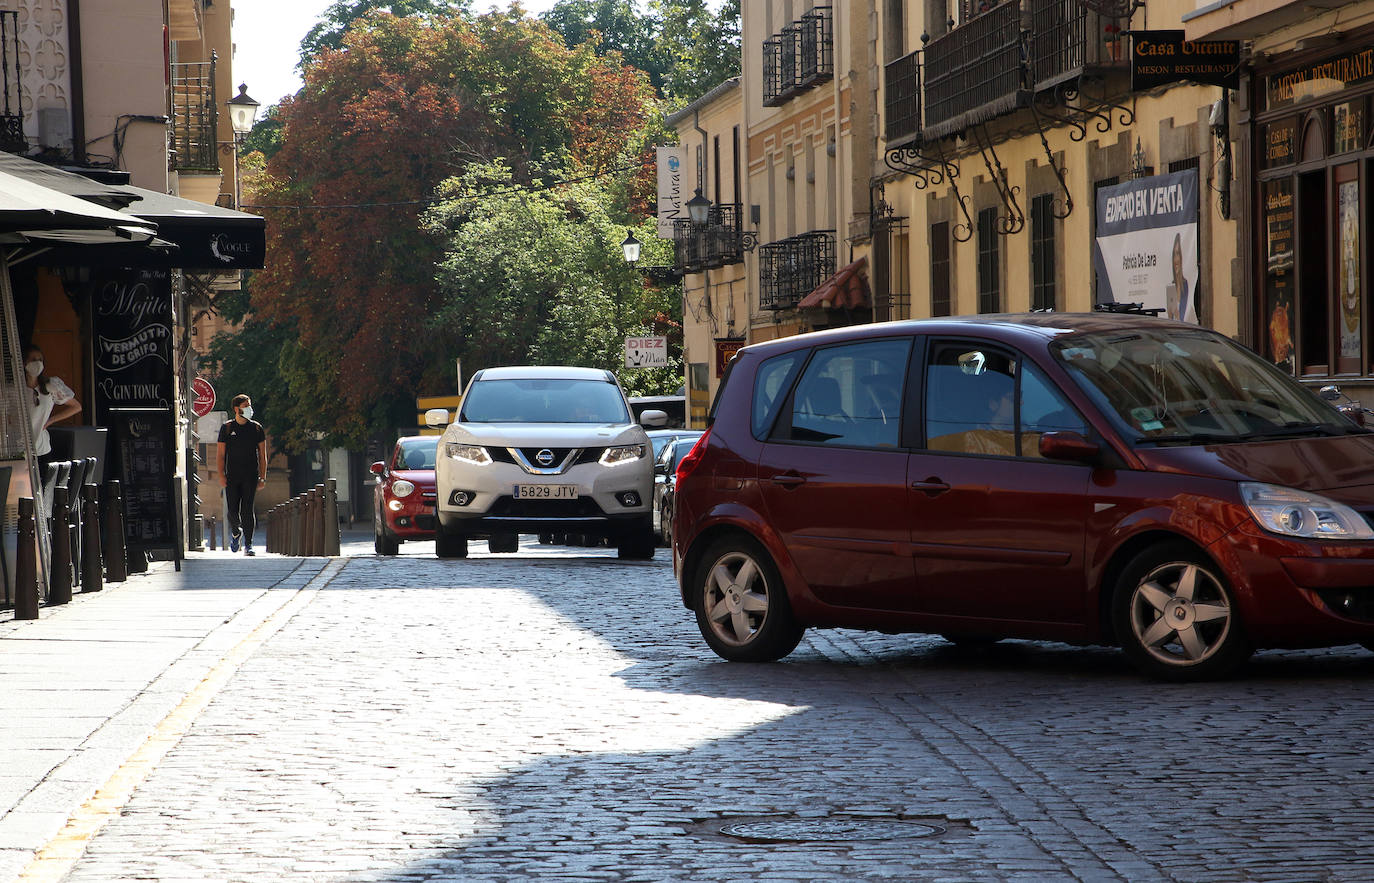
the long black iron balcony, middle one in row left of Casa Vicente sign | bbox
[923,0,1031,140]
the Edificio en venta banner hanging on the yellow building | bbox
[1092,169,1198,321]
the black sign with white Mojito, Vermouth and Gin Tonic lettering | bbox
[92,269,174,416]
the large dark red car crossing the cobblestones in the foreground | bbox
[673,313,1374,680]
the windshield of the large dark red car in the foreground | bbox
[1051,325,1366,444]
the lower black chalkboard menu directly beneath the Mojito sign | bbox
[110,409,181,560]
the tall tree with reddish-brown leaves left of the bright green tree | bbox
[251,10,665,445]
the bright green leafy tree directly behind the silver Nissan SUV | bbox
[427,163,682,394]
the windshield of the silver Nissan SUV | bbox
[458,379,631,423]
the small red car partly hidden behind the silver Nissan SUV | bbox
[372,435,438,555]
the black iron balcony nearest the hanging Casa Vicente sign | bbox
[1029,0,1131,92]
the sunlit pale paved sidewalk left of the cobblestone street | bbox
[0,551,341,880]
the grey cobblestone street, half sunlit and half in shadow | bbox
[8,545,1374,880]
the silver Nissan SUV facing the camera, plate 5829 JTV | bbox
[426,367,666,559]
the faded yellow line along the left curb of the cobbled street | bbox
[16,558,345,883]
